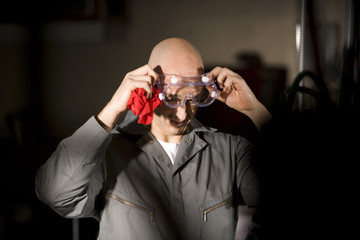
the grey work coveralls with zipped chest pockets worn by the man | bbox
[36,113,258,240]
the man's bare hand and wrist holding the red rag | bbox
[97,64,158,132]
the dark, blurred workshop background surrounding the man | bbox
[0,0,359,239]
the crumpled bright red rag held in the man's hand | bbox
[128,86,162,125]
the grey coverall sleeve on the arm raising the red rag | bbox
[35,117,111,217]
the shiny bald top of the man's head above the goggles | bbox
[148,38,204,75]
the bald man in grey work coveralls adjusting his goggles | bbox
[36,38,271,240]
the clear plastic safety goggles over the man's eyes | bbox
[156,73,217,108]
